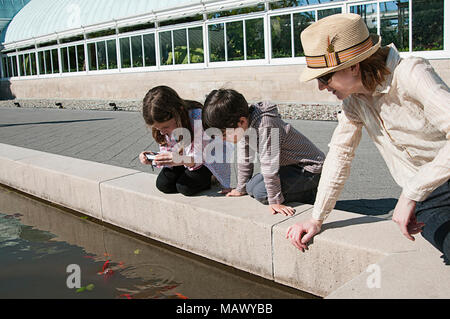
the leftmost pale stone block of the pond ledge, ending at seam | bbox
[0,144,138,219]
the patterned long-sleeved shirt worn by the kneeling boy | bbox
[236,102,325,204]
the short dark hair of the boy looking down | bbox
[202,89,249,131]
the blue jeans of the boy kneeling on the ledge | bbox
[245,165,320,205]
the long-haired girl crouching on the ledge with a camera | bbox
[139,86,230,196]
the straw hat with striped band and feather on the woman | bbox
[300,13,381,82]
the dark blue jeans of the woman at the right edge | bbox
[416,180,450,264]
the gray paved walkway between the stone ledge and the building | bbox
[0,107,401,217]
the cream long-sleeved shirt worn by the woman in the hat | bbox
[313,45,450,220]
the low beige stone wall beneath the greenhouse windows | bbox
[0,60,450,104]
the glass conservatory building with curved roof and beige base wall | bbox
[0,0,450,108]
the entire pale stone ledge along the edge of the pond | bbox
[0,144,450,298]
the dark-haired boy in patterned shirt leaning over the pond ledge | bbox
[203,89,325,216]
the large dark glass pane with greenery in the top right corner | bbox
[412,0,444,51]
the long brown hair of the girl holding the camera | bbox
[142,86,202,145]
